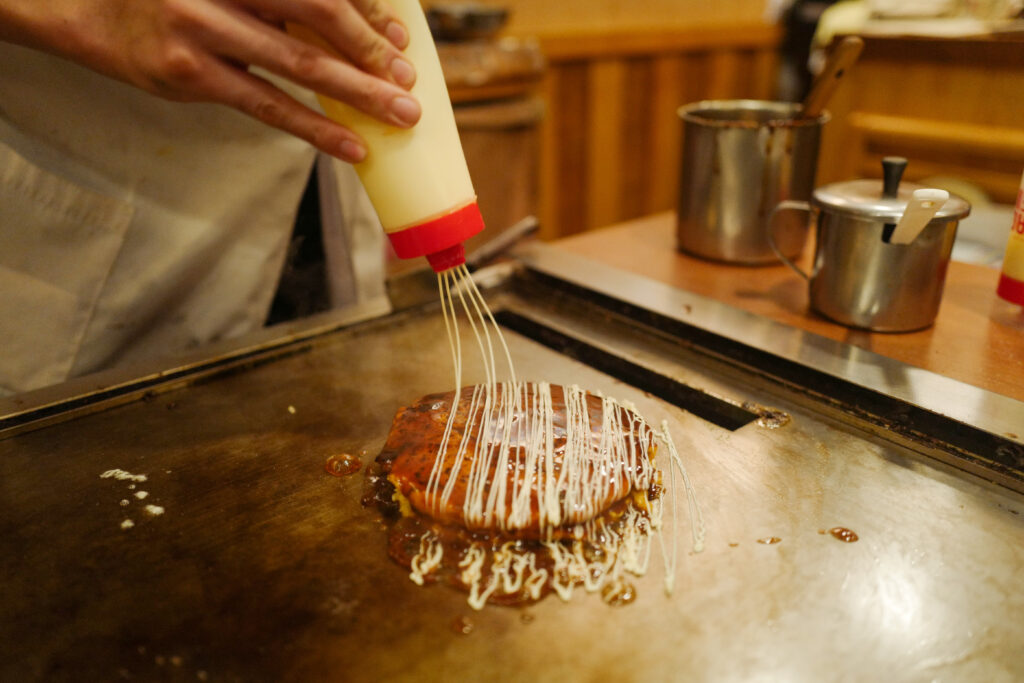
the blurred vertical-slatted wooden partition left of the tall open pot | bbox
[540,25,779,239]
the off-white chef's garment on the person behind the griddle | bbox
[0,42,386,394]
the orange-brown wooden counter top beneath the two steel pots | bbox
[553,212,1024,403]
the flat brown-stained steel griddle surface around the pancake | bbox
[0,259,1024,681]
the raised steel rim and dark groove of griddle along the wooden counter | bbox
[509,247,1024,490]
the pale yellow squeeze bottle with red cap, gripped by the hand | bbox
[289,0,483,272]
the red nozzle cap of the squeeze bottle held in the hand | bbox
[388,201,483,272]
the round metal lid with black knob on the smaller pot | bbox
[814,180,971,223]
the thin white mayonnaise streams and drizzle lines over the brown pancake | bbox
[410,265,705,609]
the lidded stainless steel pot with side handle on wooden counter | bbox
[769,180,971,332]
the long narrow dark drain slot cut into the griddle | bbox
[495,310,758,431]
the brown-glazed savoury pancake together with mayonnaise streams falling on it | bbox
[368,266,703,609]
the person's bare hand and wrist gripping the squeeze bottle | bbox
[0,0,420,162]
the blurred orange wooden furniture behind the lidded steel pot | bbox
[818,35,1024,204]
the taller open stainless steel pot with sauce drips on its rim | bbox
[677,99,828,264]
